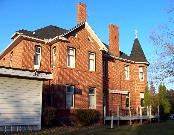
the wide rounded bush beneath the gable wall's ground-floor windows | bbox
[74,109,100,126]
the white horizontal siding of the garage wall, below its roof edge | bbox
[0,77,42,127]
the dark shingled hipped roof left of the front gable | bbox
[17,25,68,39]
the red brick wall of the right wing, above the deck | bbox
[108,60,147,115]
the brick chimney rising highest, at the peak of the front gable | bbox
[77,2,86,23]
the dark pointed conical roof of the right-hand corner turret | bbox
[130,38,148,62]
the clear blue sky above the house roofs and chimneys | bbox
[0,0,169,87]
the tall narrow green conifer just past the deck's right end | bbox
[158,84,170,120]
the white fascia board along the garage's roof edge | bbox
[0,67,53,80]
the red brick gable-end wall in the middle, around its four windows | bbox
[43,29,103,113]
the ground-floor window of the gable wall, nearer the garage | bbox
[66,86,74,109]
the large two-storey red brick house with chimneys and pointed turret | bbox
[0,3,149,122]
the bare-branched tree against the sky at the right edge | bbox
[150,1,174,83]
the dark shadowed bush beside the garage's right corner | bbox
[42,107,57,126]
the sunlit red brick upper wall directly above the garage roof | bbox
[0,40,50,72]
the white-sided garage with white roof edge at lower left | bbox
[0,67,52,132]
